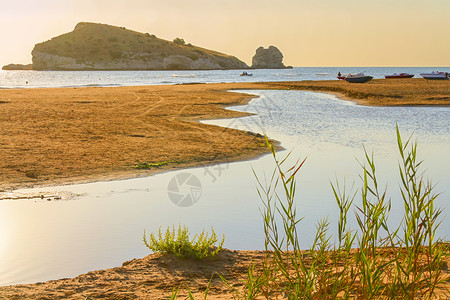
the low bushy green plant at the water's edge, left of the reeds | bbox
[143,225,225,259]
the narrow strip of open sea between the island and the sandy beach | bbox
[0,67,450,88]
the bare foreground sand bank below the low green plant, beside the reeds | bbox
[0,249,450,300]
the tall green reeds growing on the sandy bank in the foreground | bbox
[232,128,448,299]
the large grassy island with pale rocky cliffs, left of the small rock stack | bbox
[32,22,248,70]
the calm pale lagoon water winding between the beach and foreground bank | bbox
[0,69,450,285]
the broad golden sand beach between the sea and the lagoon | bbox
[0,79,450,189]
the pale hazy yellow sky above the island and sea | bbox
[0,0,450,67]
